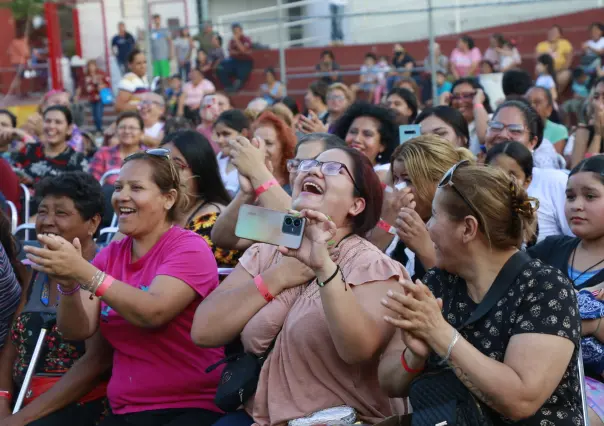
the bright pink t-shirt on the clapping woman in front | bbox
[93,226,224,414]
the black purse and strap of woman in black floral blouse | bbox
[409,251,532,426]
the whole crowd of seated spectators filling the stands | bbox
[0,15,604,426]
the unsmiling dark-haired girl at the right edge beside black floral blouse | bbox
[529,156,604,426]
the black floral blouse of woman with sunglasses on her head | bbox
[423,260,583,426]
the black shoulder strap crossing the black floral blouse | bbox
[460,251,532,328]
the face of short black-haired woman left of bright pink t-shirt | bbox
[36,195,100,242]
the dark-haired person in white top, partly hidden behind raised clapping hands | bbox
[214,109,251,197]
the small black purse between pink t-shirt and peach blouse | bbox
[206,333,279,413]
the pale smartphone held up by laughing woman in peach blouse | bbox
[235,204,306,249]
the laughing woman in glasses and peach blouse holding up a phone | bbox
[191,147,408,426]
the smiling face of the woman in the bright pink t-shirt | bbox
[111,159,176,238]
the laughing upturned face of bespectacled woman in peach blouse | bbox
[292,149,365,228]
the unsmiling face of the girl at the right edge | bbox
[564,172,604,240]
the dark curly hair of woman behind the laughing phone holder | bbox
[333,101,399,164]
